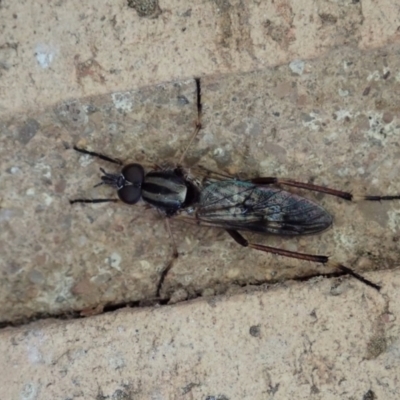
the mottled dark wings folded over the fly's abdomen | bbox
[195,180,332,235]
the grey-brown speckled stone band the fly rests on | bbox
[0,46,400,321]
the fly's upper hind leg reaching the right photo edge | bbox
[250,177,400,201]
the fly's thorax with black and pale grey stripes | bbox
[142,170,188,215]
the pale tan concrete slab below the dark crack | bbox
[0,271,400,400]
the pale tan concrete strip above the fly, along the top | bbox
[0,0,400,115]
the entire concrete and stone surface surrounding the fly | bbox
[0,1,400,400]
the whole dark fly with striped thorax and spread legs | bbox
[70,78,400,297]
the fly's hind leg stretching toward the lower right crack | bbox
[226,229,380,291]
